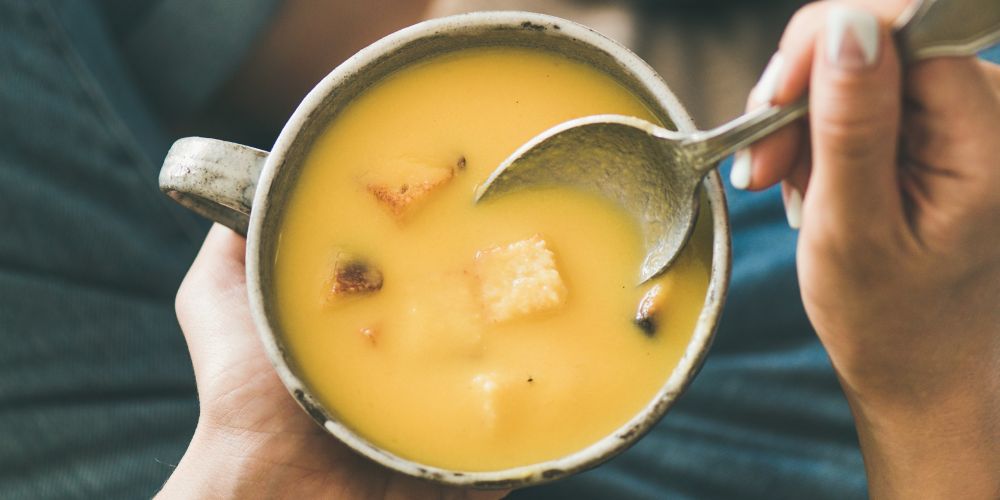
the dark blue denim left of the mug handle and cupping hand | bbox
[0,0,276,499]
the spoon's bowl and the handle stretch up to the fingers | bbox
[475,104,805,284]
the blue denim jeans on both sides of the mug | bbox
[0,0,992,499]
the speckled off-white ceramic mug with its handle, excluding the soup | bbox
[160,12,731,488]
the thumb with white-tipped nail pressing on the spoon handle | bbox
[804,5,902,234]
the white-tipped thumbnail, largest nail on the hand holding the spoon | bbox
[826,5,879,69]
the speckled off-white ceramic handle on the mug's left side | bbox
[160,137,268,236]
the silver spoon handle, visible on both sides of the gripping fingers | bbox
[684,0,1000,174]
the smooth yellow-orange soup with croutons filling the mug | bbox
[275,48,711,471]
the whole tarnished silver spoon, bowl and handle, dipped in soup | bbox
[475,0,1000,283]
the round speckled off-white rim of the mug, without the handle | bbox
[239,11,731,488]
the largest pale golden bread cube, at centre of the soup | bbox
[474,235,566,322]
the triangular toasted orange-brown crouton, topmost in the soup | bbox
[364,157,455,220]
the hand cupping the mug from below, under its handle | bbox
[158,224,506,500]
